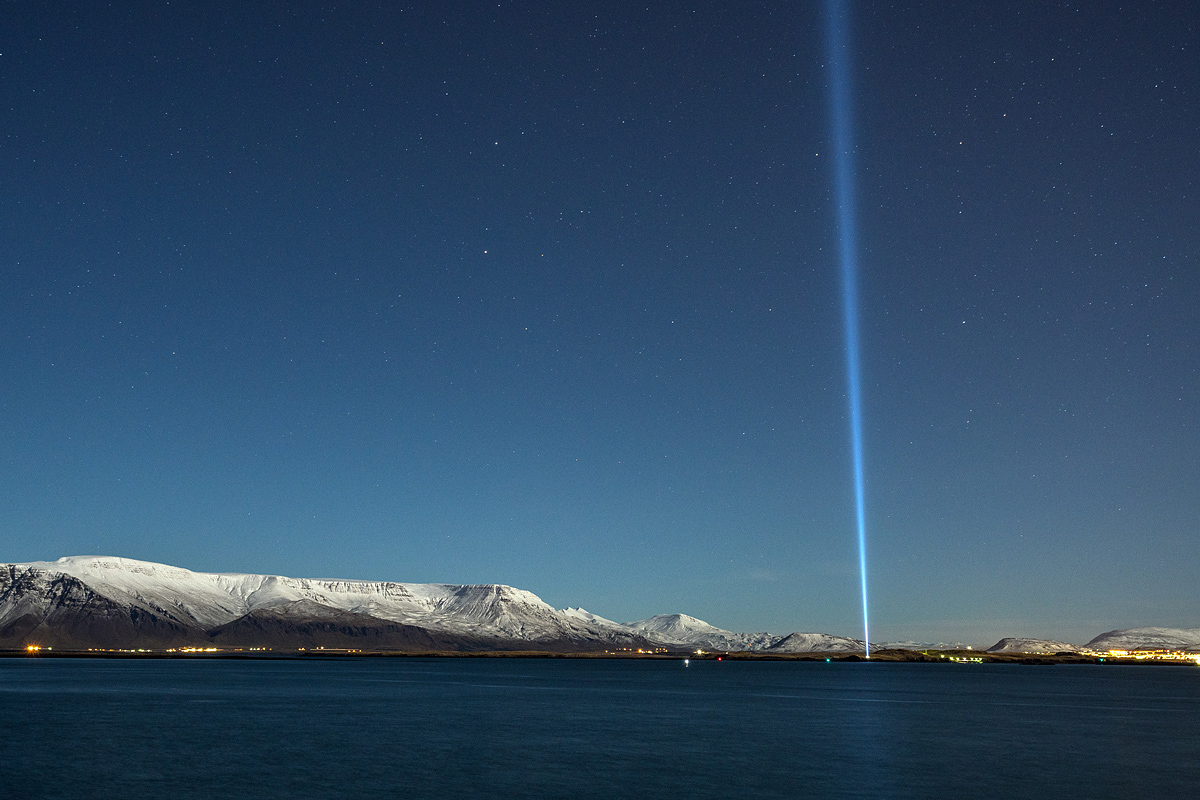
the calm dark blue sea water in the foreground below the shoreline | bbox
[0,658,1200,798]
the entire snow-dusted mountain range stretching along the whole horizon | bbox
[0,555,1200,655]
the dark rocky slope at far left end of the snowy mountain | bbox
[0,565,203,650]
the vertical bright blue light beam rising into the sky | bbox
[826,0,871,658]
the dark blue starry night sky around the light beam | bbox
[0,0,1200,645]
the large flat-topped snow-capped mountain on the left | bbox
[0,557,653,650]
